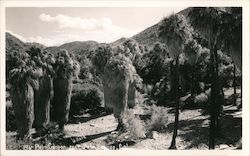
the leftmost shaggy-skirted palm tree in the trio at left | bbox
[9,52,42,141]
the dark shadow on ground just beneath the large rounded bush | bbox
[68,107,112,124]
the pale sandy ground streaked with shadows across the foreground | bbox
[7,89,242,150]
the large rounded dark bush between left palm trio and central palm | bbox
[70,83,103,116]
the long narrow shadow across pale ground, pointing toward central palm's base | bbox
[52,131,113,147]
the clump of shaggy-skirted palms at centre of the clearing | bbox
[93,45,141,130]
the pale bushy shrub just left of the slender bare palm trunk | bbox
[146,105,168,133]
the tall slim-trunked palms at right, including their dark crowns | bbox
[159,7,242,149]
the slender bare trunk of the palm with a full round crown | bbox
[169,56,179,149]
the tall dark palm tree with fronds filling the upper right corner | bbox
[188,8,241,149]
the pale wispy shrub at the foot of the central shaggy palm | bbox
[124,109,146,140]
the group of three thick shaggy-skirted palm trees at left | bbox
[8,47,79,141]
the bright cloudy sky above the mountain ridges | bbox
[6,7,185,46]
